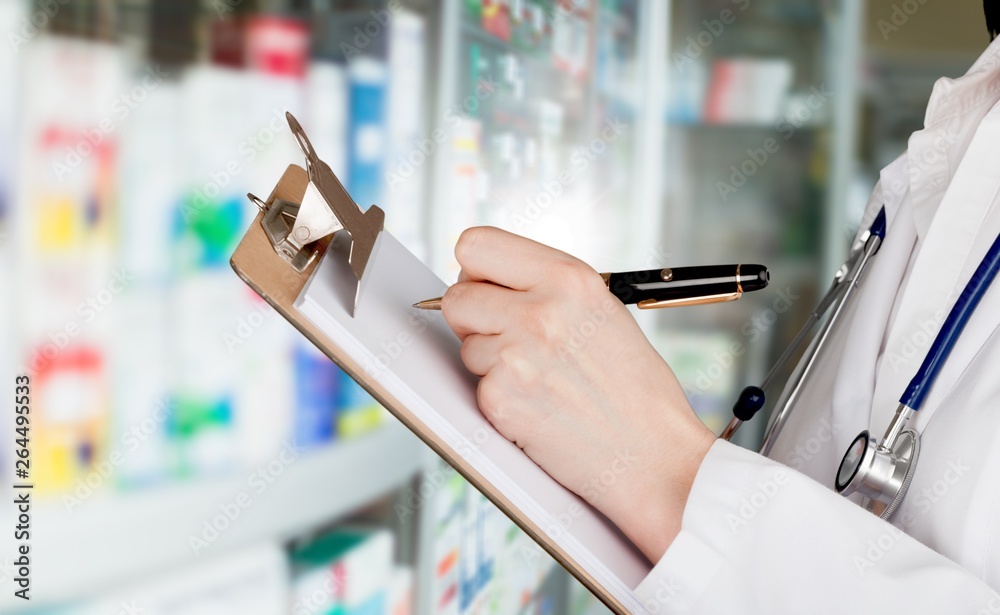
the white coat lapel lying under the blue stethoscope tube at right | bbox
[869,89,1000,432]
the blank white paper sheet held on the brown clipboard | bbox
[296,232,651,613]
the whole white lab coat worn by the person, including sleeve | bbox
[636,41,1000,615]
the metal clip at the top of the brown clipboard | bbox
[247,112,385,314]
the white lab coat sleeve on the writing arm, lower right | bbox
[635,441,1000,615]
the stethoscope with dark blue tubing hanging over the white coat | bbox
[719,207,1000,519]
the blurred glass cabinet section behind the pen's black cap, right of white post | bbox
[654,0,871,448]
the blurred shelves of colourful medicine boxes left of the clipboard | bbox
[0,0,440,613]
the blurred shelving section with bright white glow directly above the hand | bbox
[429,0,666,282]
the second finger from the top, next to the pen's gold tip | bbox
[441,282,523,340]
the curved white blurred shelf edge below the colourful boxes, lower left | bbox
[0,420,427,612]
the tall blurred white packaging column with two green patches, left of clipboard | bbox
[169,68,250,476]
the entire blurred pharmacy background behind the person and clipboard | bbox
[0,0,988,615]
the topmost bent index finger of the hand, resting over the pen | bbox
[455,226,585,290]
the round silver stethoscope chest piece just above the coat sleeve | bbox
[835,429,920,519]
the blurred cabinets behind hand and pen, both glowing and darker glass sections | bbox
[429,0,870,446]
